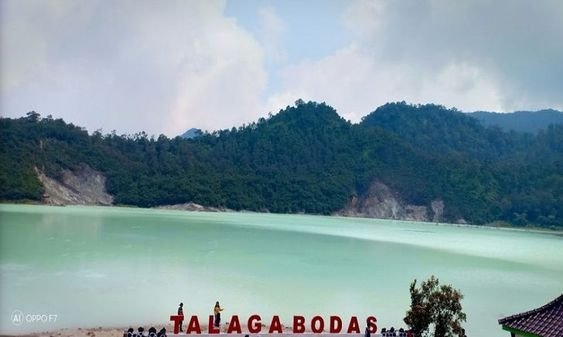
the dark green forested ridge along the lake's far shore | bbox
[0,102,563,228]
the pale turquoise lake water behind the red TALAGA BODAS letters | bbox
[0,205,563,337]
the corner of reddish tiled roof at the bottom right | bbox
[498,294,563,337]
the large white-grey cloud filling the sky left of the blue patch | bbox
[0,1,266,136]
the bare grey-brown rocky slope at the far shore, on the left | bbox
[35,165,113,205]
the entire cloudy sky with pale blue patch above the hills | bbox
[0,0,563,136]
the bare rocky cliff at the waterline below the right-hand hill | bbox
[338,181,444,222]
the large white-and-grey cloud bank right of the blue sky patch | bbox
[269,0,563,121]
